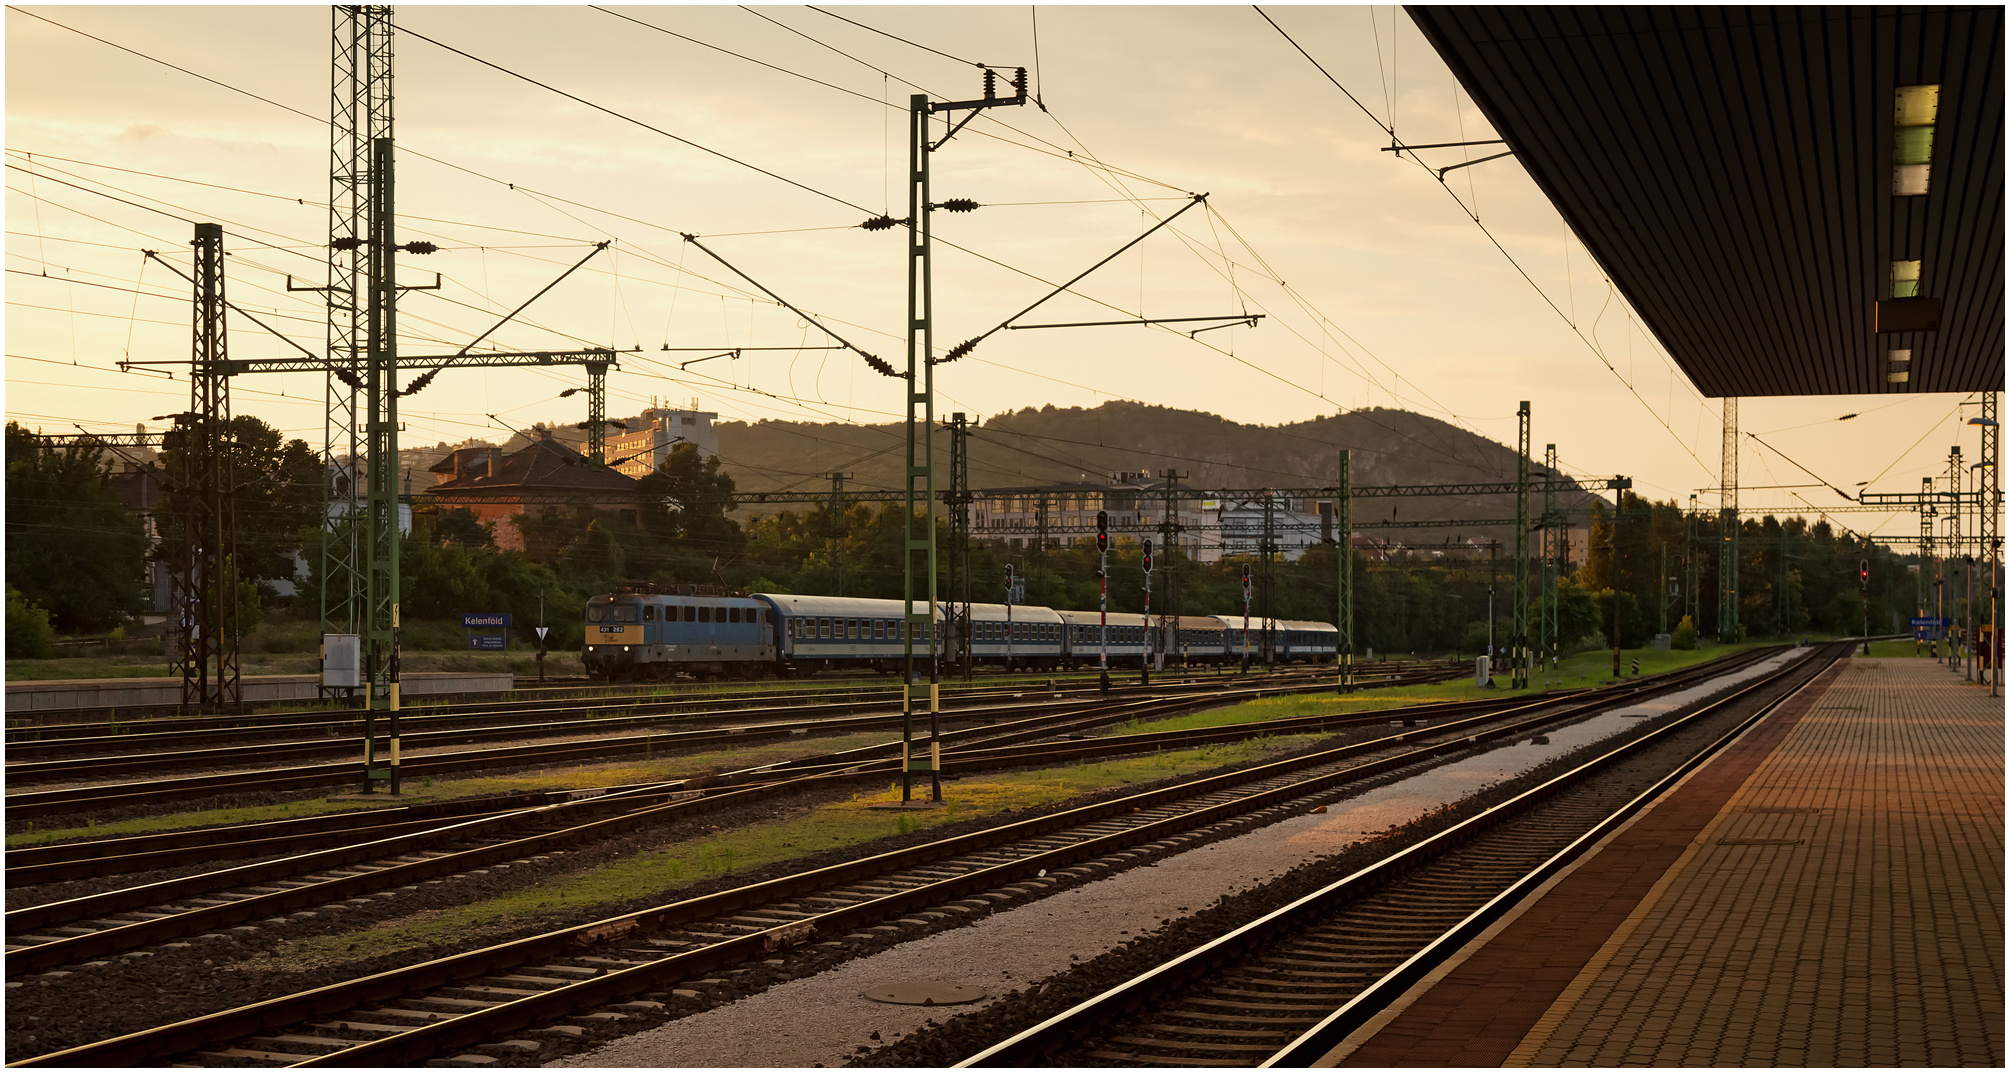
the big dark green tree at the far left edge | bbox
[6,422,147,633]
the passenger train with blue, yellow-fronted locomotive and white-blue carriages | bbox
[581,593,1339,681]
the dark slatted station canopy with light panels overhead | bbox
[1409,6,2004,398]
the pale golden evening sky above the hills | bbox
[6,4,1978,534]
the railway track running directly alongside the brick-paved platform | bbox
[959,643,1847,1067]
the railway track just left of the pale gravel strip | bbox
[10,647,1784,1065]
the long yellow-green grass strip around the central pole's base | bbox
[273,735,1315,962]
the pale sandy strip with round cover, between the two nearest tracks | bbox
[553,653,1799,1069]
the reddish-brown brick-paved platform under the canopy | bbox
[1321,659,2004,1067]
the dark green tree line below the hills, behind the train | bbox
[6,416,1916,655]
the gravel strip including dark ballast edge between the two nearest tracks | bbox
[549,657,1787,1067]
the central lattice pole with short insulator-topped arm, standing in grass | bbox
[900,68,1027,804]
